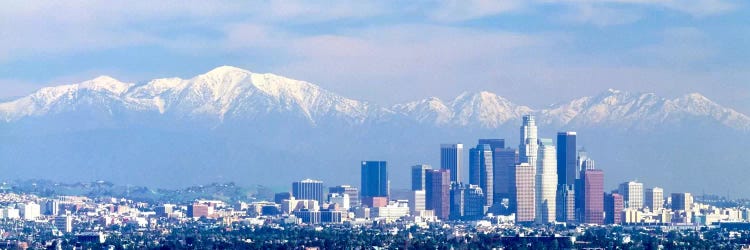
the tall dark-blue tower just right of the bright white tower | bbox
[557,131,577,185]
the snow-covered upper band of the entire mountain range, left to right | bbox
[0,66,750,131]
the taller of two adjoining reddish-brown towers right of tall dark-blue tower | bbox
[582,169,604,224]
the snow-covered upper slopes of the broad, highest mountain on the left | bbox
[0,66,369,125]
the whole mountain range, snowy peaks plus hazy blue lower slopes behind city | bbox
[0,66,750,194]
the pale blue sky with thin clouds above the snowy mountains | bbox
[0,0,750,114]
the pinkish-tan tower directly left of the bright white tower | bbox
[514,162,536,223]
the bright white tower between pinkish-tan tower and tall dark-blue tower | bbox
[535,139,557,223]
